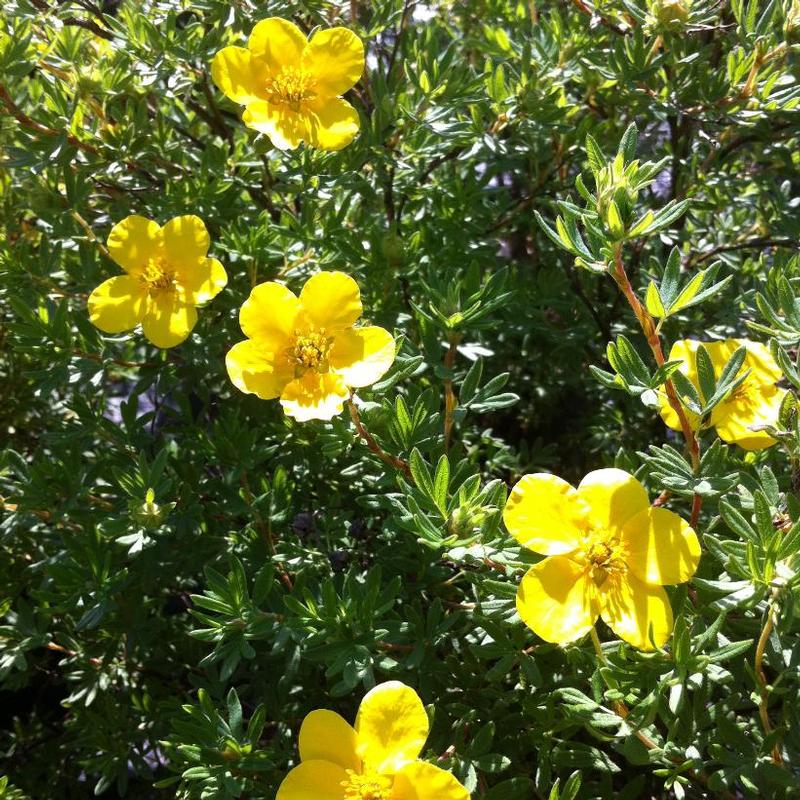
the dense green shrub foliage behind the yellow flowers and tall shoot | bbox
[0,0,800,800]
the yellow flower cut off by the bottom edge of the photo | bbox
[276,681,469,800]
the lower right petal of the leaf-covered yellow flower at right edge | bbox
[711,378,786,450]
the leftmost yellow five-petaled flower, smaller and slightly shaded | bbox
[89,215,228,347]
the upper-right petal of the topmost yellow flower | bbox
[303,28,364,97]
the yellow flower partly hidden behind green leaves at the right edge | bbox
[659,339,786,450]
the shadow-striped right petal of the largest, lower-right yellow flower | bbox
[620,508,700,585]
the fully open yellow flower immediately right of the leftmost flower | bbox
[225,272,394,422]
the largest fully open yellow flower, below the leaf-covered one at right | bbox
[503,469,700,650]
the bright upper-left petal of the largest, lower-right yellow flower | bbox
[503,472,589,556]
